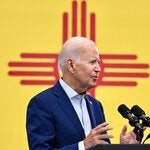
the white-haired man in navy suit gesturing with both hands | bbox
[26,37,136,150]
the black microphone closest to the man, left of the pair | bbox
[118,104,143,130]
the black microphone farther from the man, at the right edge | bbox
[131,105,150,127]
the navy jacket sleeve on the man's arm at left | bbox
[26,98,78,150]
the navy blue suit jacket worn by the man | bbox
[26,81,109,150]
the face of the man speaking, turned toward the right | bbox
[73,47,101,89]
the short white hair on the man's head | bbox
[58,37,95,72]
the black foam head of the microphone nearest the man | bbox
[118,104,131,118]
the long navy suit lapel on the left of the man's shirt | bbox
[54,82,85,138]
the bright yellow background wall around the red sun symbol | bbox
[0,0,150,150]
